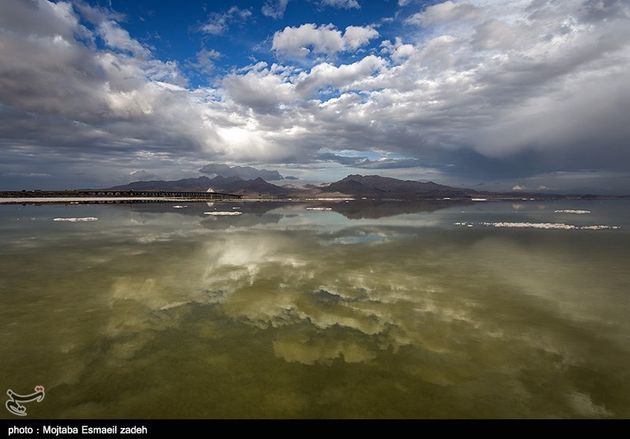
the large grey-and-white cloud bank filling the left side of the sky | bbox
[0,0,286,184]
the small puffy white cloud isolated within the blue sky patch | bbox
[272,23,379,57]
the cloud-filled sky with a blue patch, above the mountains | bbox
[0,0,630,194]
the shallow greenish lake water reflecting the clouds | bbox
[0,201,630,418]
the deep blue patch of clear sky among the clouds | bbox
[102,0,434,88]
